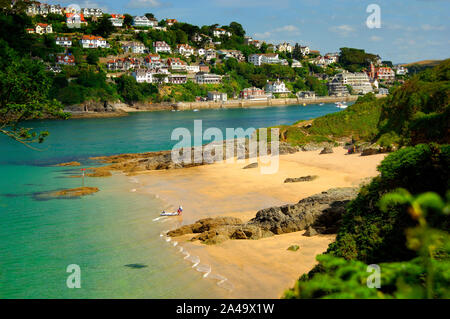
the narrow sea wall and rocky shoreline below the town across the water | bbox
[65,95,384,119]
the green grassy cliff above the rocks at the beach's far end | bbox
[280,59,450,147]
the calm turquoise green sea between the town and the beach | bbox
[0,104,339,298]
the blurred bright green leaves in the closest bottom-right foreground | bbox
[284,189,450,299]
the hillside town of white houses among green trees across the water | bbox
[22,2,408,103]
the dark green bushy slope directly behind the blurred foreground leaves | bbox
[328,144,450,263]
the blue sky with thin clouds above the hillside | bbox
[47,0,450,63]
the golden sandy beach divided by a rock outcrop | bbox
[135,147,386,298]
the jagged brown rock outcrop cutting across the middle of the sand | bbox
[168,188,357,244]
